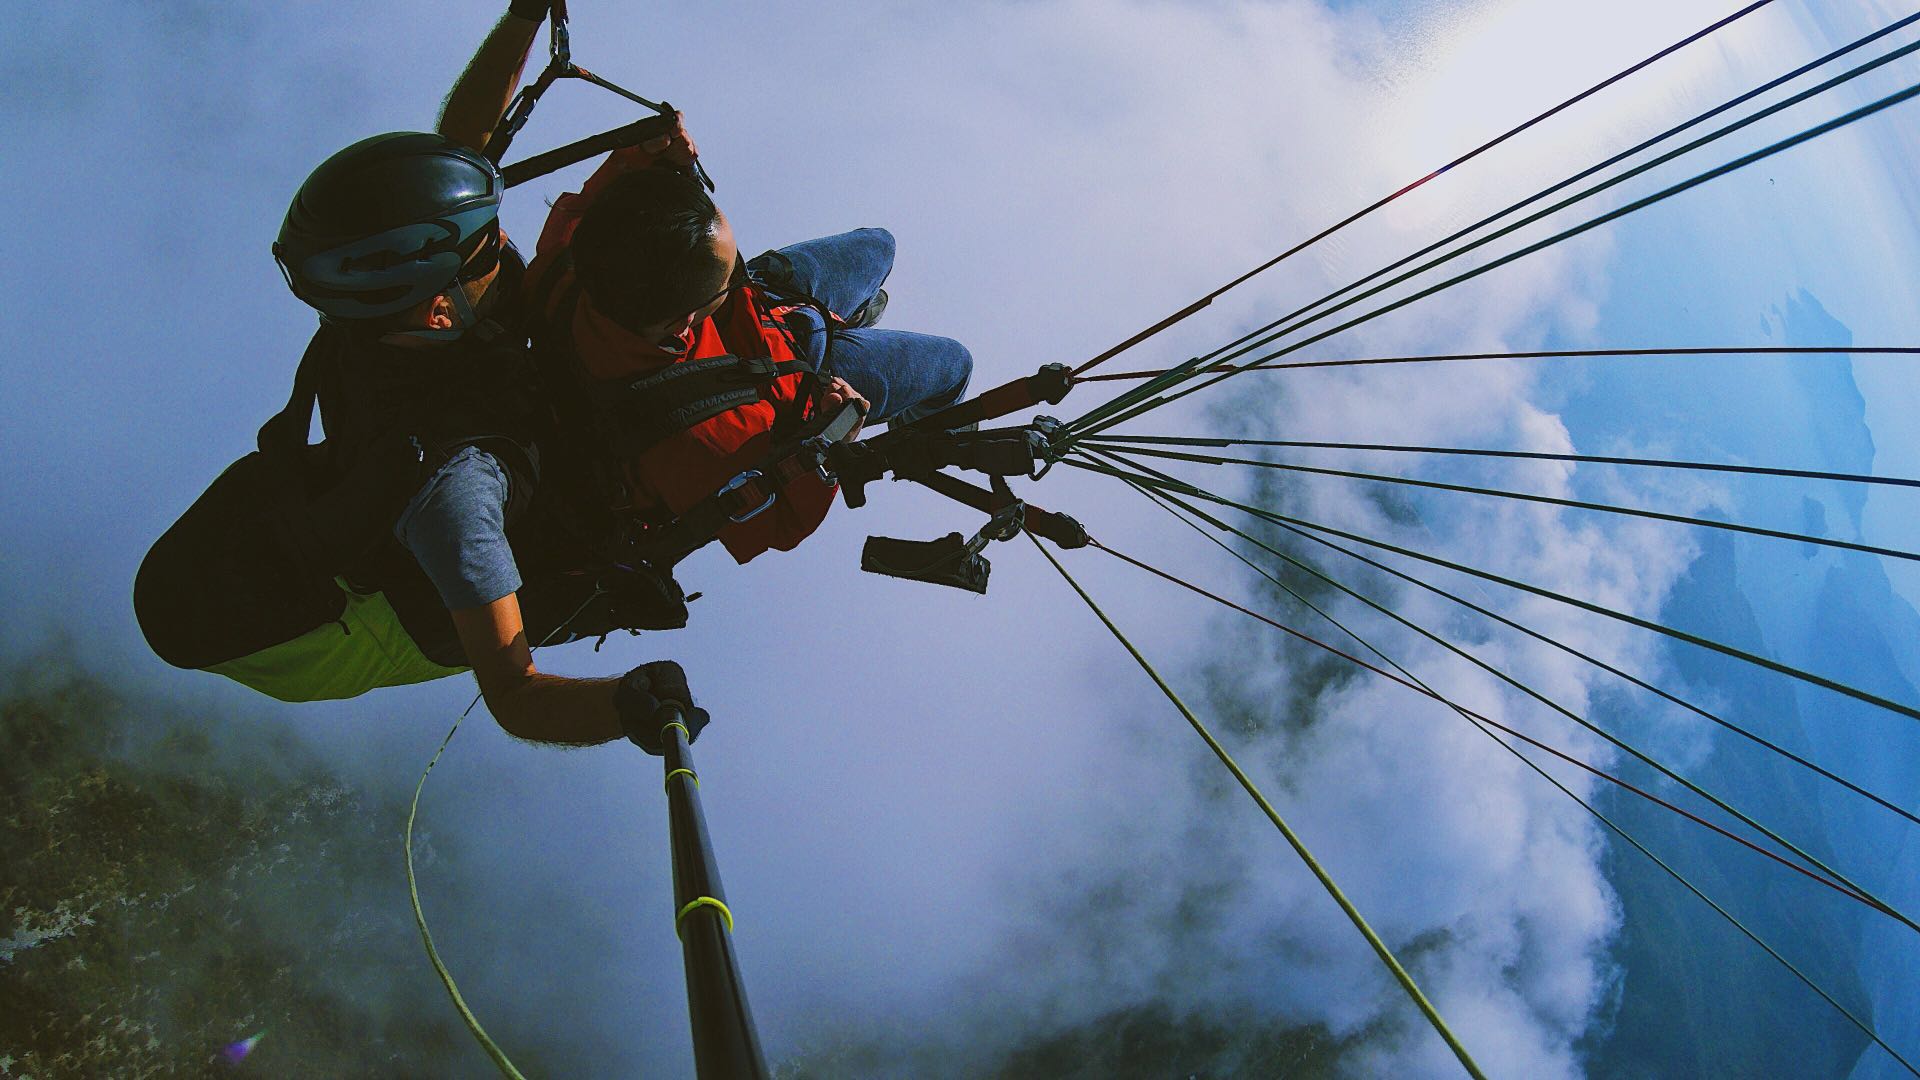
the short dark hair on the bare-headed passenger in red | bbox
[570,167,720,327]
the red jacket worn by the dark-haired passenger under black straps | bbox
[528,148,835,563]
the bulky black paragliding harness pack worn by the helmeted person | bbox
[134,305,687,669]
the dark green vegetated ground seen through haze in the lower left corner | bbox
[0,657,474,1078]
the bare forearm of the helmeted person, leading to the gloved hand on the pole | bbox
[453,592,624,746]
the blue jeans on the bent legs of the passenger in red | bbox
[747,229,973,423]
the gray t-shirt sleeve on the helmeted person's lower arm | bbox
[394,446,520,611]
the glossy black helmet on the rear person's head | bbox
[273,131,505,321]
